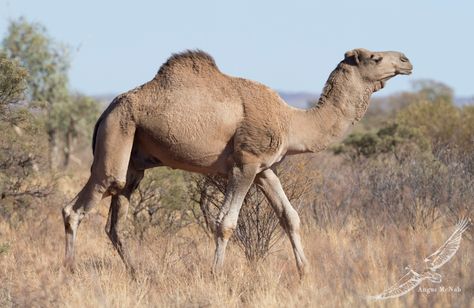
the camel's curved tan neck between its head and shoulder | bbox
[288,63,377,154]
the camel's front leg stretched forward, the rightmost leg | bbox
[255,169,309,277]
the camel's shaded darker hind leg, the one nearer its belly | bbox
[105,167,144,277]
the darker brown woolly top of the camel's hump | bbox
[157,49,218,76]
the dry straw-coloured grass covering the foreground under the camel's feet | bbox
[0,203,474,307]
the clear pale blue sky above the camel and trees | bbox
[0,0,474,96]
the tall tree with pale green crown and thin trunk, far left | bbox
[2,18,69,167]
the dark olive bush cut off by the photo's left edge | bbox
[0,53,51,223]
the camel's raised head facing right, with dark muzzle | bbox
[344,48,413,90]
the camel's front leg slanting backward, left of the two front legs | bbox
[212,165,257,274]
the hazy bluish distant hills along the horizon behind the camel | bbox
[93,91,474,109]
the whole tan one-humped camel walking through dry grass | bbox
[62,49,412,275]
